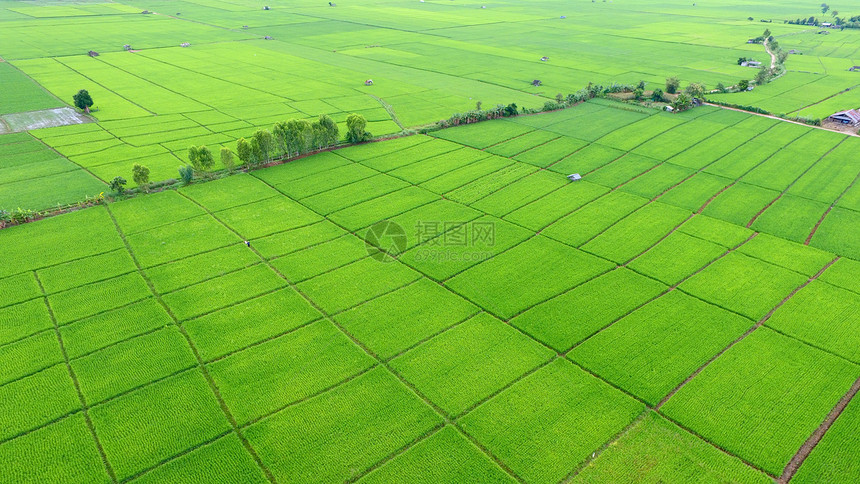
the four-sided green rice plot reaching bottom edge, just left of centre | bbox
[244,367,443,481]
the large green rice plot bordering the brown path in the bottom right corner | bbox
[662,328,860,475]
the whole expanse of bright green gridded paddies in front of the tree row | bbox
[0,99,860,482]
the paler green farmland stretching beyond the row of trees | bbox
[5,0,857,210]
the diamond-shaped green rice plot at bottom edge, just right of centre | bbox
[460,359,645,482]
